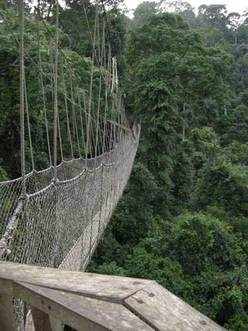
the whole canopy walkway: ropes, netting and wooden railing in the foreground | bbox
[0,0,225,331]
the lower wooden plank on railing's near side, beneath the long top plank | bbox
[15,283,152,331]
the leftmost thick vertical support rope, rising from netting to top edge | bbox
[19,0,26,196]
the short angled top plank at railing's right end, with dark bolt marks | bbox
[125,282,224,331]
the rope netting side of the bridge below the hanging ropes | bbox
[0,126,138,270]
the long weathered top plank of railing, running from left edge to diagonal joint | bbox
[0,262,151,302]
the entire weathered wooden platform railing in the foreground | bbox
[0,262,223,331]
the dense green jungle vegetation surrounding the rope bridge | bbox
[0,0,248,330]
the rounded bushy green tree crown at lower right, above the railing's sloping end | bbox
[169,213,244,275]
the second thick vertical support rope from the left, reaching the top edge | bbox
[53,0,59,182]
